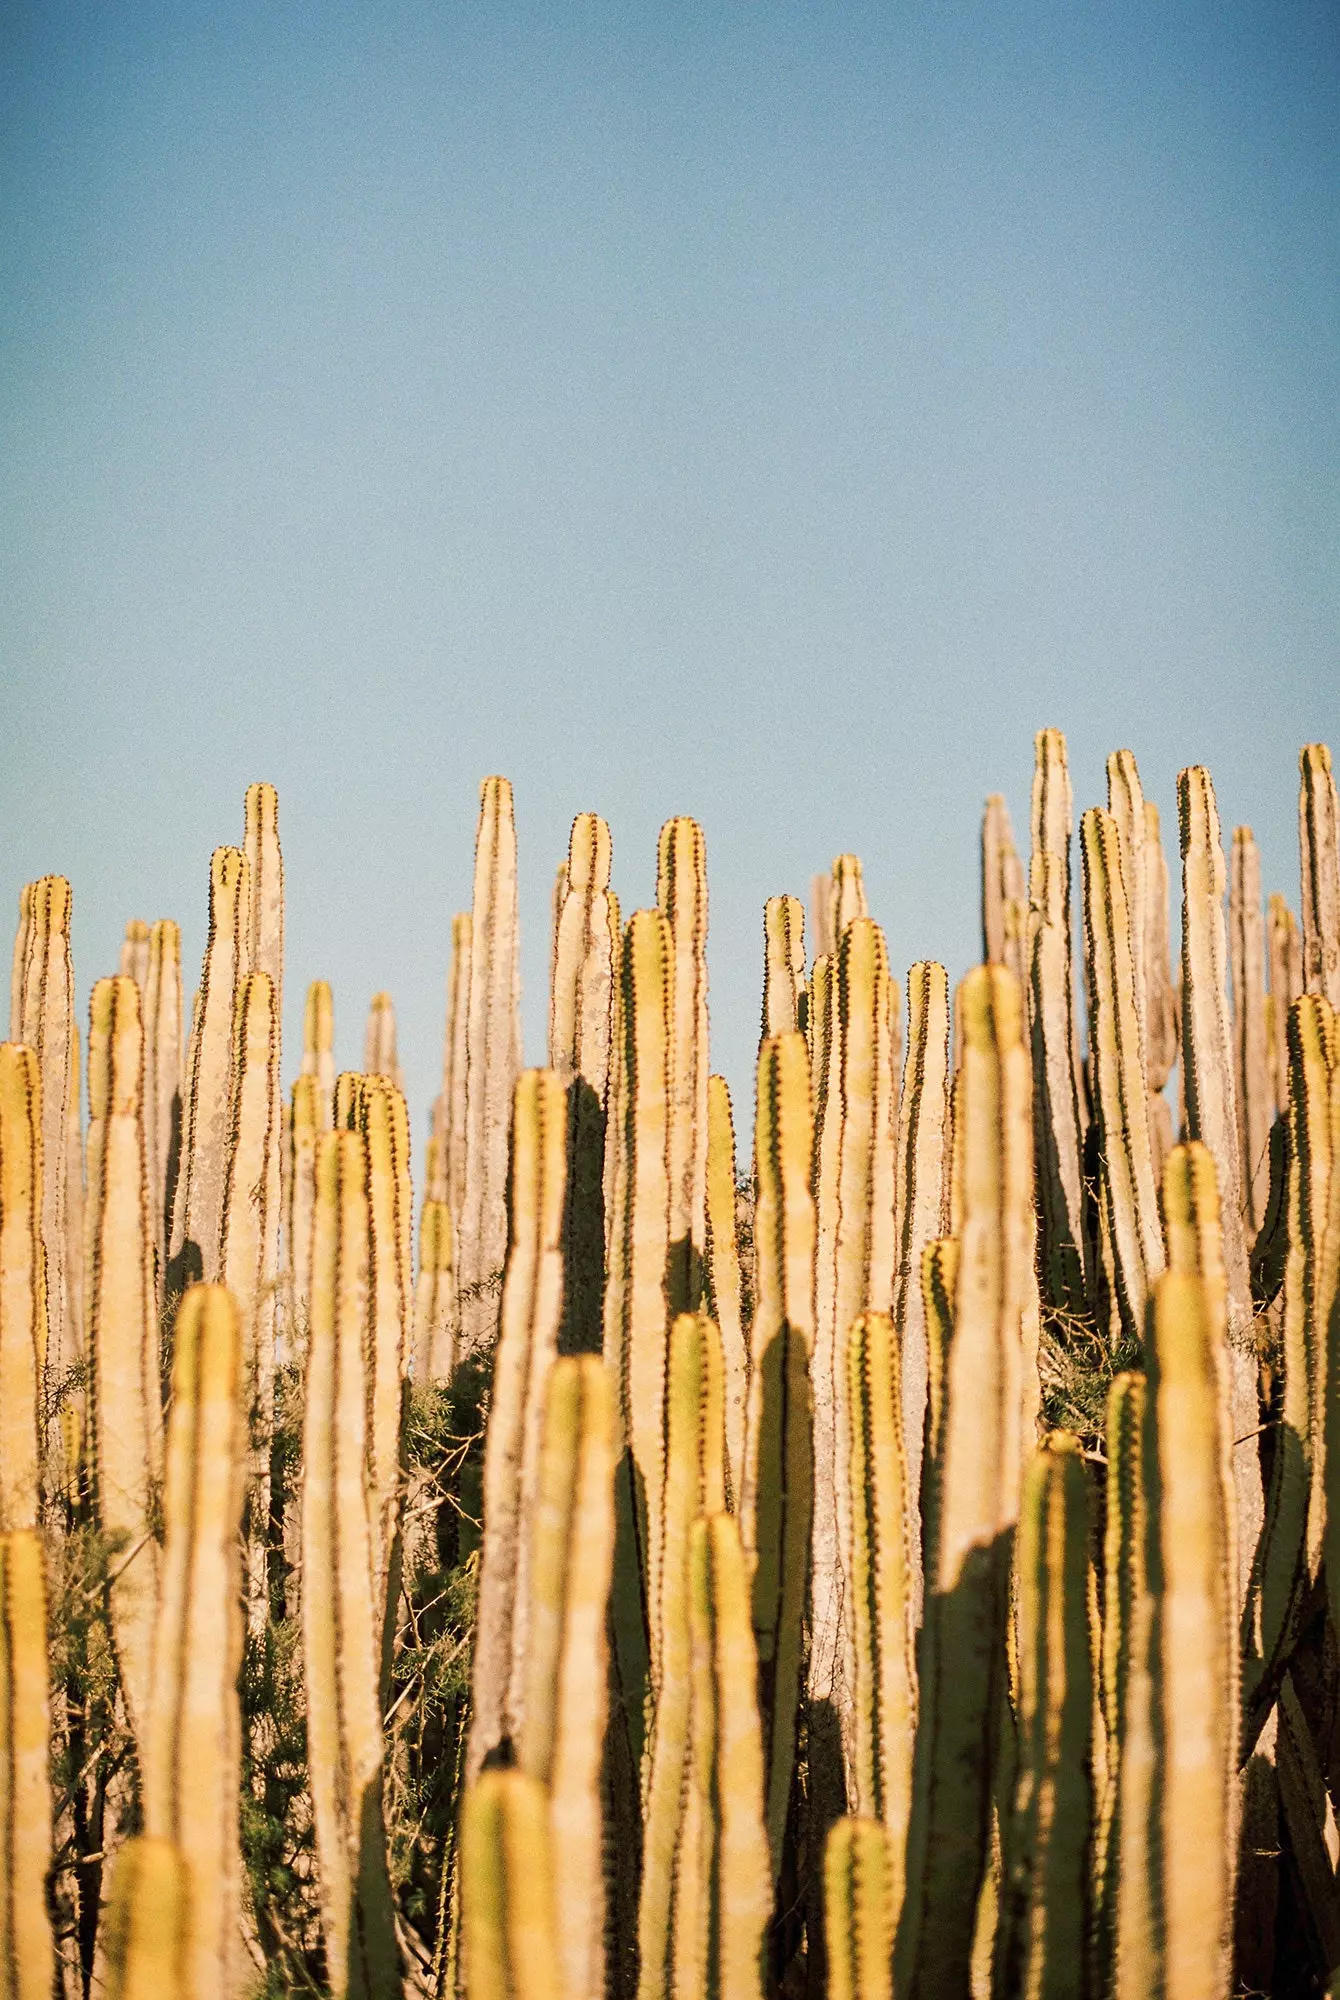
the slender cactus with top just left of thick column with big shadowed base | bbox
[894,960,950,1560]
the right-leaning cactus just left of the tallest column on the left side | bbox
[170,848,252,1292]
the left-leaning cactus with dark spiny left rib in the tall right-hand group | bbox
[1080,806,1164,1340]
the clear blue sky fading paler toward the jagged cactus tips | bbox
[0,0,1340,1152]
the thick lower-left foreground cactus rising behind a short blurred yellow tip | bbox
[140,1286,246,2000]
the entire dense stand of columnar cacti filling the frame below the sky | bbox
[0,730,1340,2000]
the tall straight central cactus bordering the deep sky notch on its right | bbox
[656,820,708,1314]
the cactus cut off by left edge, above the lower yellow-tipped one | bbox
[0,1042,46,1534]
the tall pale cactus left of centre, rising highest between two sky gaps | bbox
[462,778,522,1354]
